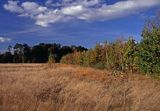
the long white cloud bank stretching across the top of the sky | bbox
[4,0,160,27]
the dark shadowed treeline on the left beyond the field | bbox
[0,43,87,63]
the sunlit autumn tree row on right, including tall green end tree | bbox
[61,15,160,74]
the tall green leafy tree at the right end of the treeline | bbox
[138,14,160,73]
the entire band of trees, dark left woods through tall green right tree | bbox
[0,13,160,74]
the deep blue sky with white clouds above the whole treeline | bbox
[0,0,160,51]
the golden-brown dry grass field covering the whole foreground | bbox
[0,64,160,111]
